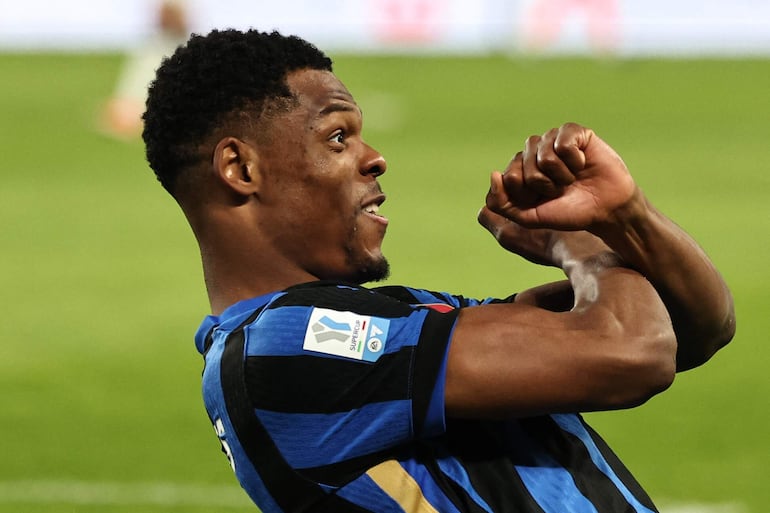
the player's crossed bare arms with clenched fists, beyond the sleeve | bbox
[446,124,735,416]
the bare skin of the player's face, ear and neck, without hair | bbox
[178,71,387,313]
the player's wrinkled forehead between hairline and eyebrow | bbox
[286,69,360,117]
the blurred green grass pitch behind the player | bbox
[0,54,770,513]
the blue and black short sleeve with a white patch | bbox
[244,283,457,480]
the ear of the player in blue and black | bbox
[212,137,260,196]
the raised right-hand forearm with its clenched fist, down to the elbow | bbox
[488,124,735,371]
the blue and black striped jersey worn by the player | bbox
[196,282,656,513]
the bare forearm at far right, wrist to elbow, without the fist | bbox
[594,190,735,370]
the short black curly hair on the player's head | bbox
[142,29,332,195]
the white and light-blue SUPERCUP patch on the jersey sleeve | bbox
[302,308,390,362]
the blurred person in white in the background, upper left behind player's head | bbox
[100,0,190,139]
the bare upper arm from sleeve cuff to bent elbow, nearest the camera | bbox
[445,270,676,417]
